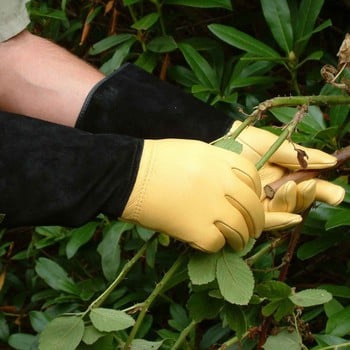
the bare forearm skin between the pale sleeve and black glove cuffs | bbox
[0,31,104,126]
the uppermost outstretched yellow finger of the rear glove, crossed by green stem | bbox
[232,121,337,170]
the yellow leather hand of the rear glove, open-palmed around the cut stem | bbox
[232,121,345,230]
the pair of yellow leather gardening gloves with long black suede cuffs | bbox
[0,65,344,252]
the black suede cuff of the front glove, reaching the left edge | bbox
[0,112,143,227]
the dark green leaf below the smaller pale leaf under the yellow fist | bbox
[187,292,223,322]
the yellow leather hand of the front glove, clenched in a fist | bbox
[121,139,264,252]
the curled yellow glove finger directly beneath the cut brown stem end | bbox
[263,181,297,213]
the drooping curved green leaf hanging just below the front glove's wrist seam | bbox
[97,221,133,281]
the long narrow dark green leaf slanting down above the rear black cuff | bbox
[178,43,219,89]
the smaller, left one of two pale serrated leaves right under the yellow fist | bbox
[188,252,218,285]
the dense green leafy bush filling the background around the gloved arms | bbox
[0,0,350,350]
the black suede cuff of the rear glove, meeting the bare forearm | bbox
[76,64,233,142]
